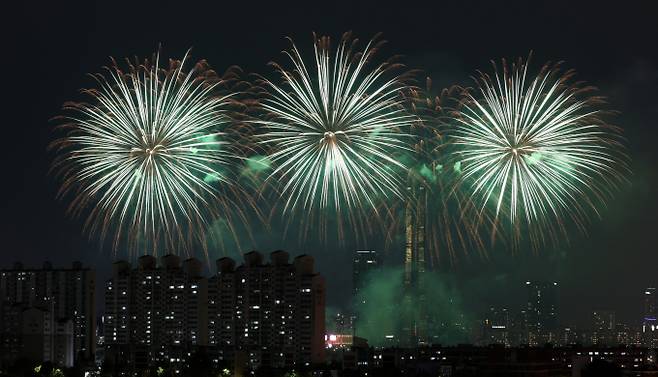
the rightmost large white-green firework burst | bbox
[453,61,627,244]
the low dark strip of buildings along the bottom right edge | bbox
[356,345,658,377]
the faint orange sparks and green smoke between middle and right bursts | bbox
[376,82,495,265]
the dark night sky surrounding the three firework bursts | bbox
[0,1,658,324]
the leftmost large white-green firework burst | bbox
[51,50,250,253]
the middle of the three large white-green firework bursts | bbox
[257,35,413,238]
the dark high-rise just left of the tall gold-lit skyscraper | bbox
[352,250,381,334]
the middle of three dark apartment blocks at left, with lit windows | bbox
[103,254,208,368]
